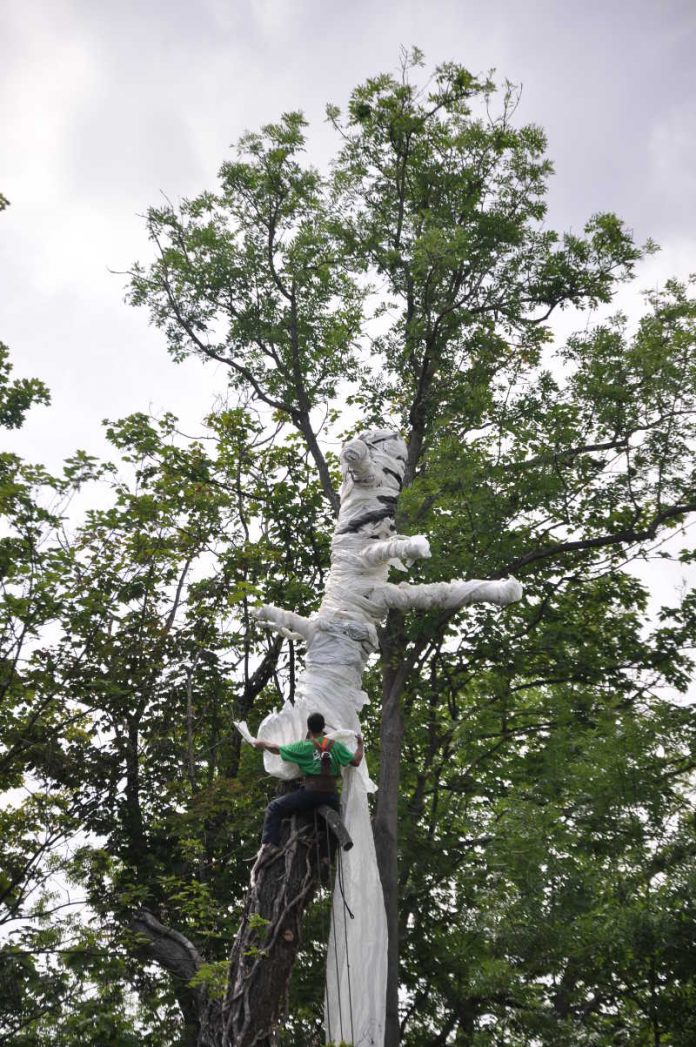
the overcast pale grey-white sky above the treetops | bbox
[0,0,696,475]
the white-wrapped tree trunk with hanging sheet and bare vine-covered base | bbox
[223,430,521,1047]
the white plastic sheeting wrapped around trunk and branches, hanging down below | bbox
[240,430,521,1047]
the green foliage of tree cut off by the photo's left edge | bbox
[0,339,133,1047]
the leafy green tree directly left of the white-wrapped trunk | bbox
[2,397,337,1047]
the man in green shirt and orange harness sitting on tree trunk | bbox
[254,713,363,859]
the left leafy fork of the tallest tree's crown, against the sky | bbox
[131,113,362,423]
